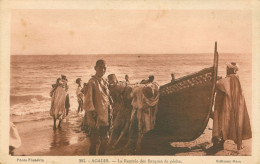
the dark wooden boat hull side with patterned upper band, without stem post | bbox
[155,67,214,141]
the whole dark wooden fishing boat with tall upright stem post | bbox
[141,43,218,155]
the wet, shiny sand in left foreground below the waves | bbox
[14,113,86,155]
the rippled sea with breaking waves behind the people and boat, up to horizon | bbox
[10,53,252,123]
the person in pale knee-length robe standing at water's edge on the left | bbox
[50,78,66,130]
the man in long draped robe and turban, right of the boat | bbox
[207,63,252,154]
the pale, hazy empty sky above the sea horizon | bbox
[11,9,252,55]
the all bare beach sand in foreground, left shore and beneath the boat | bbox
[14,113,251,156]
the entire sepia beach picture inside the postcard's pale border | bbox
[0,0,257,164]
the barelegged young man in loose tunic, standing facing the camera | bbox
[83,60,112,155]
